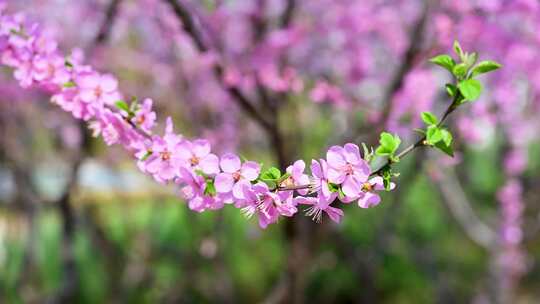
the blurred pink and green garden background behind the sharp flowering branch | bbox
[0,0,540,303]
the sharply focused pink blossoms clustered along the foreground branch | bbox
[0,8,397,228]
